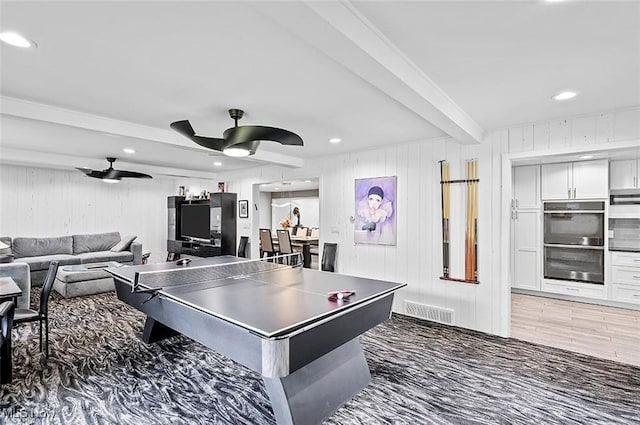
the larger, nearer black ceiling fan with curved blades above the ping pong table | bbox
[170,109,304,157]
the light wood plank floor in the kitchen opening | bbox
[511,294,640,367]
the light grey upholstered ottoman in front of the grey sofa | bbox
[53,261,123,298]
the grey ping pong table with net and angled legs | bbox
[107,256,406,424]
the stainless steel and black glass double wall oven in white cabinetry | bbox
[543,201,605,285]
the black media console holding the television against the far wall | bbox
[167,193,237,260]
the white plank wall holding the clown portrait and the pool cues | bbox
[219,108,640,336]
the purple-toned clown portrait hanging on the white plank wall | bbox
[353,176,396,245]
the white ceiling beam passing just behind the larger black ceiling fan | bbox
[0,96,304,168]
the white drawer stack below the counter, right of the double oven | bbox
[611,251,640,304]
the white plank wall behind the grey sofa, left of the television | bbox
[0,165,178,262]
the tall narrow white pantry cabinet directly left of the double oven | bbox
[511,165,542,291]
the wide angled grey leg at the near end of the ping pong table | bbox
[262,338,371,424]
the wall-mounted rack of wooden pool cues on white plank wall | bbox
[440,159,480,283]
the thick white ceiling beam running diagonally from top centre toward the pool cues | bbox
[252,1,484,144]
